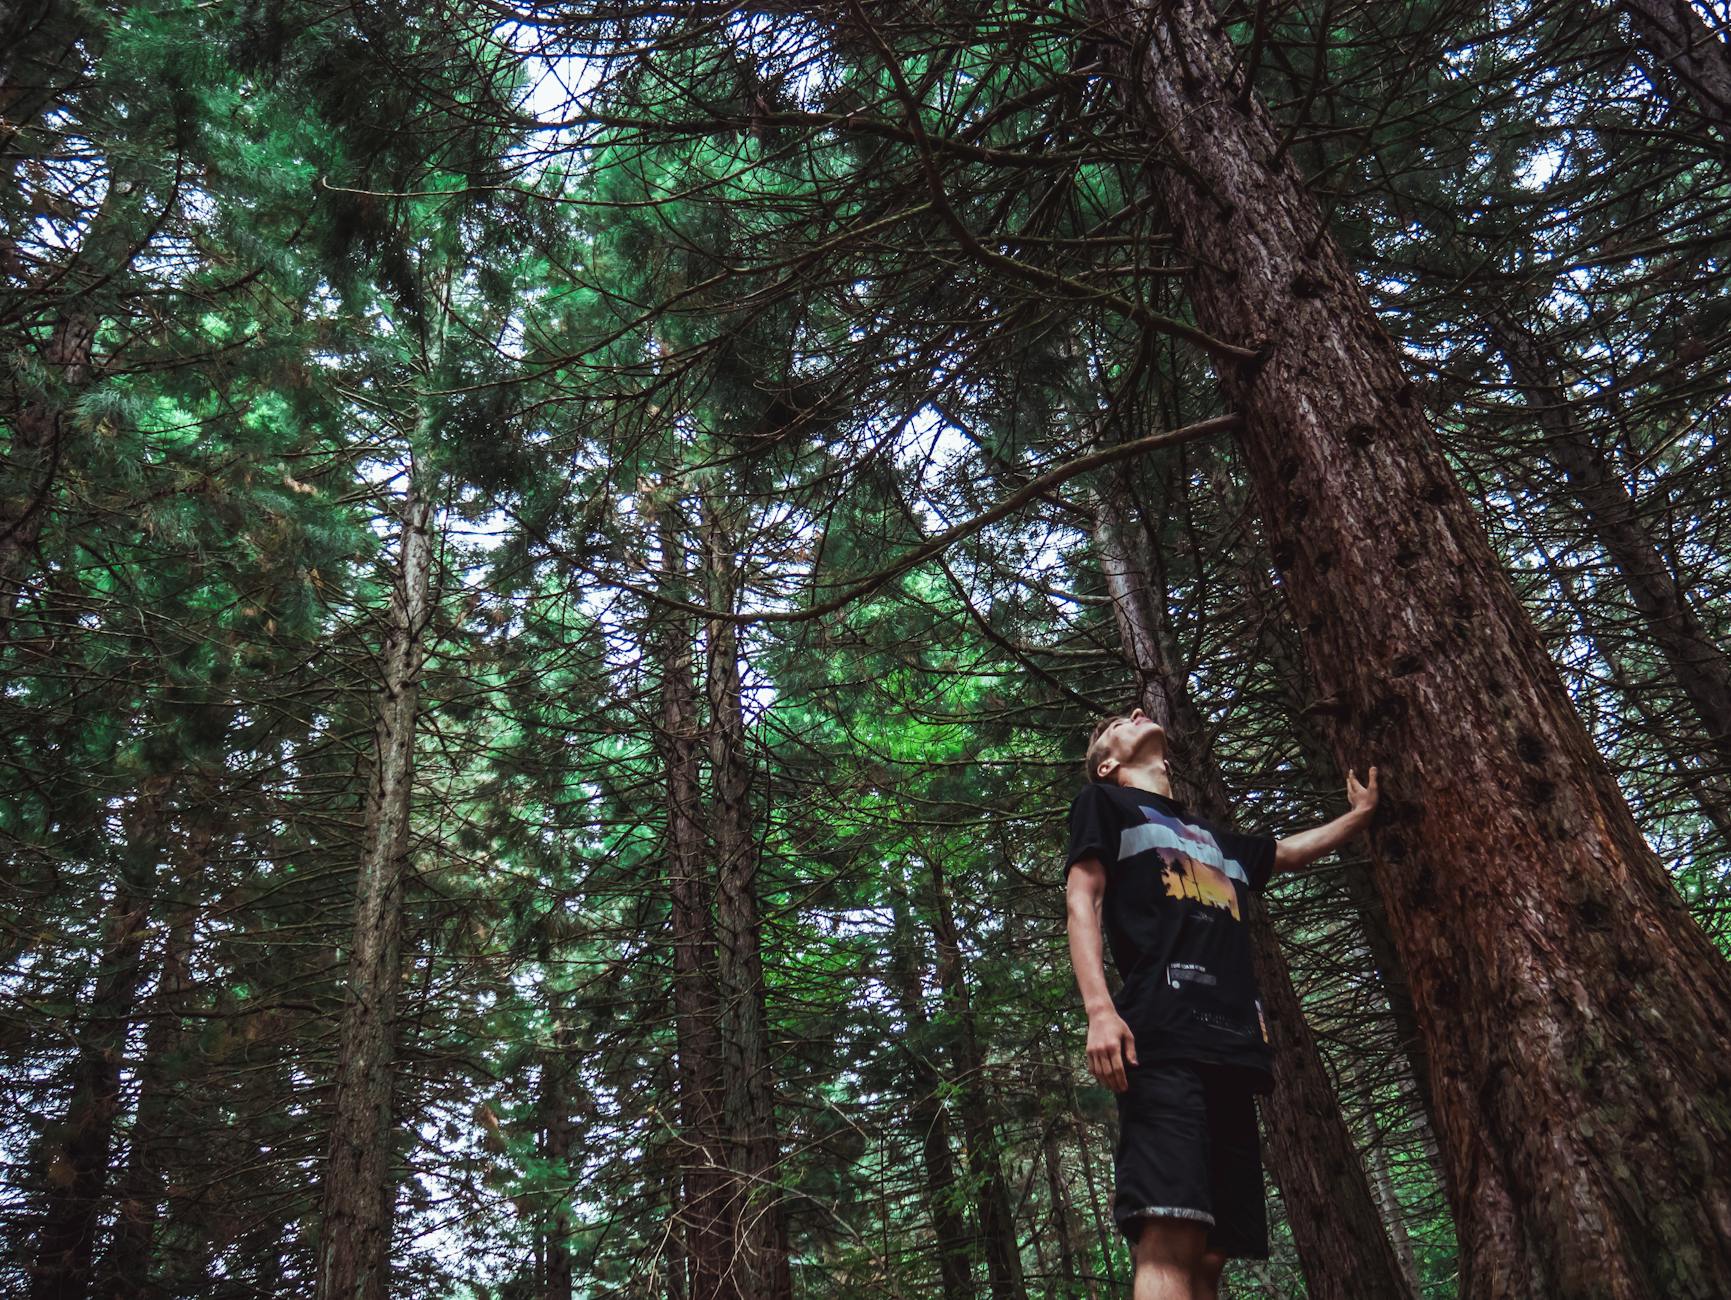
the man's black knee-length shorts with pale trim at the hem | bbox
[1111,1061,1269,1260]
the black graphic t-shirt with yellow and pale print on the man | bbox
[1065,782,1274,1087]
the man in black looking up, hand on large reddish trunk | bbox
[1065,710,1376,1300]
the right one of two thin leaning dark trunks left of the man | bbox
[928,860,1028,1300]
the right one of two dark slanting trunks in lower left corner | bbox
[102,805,216,1300]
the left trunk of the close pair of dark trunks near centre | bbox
[656,507,737,1300]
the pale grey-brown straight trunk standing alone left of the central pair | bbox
[317,486,433,1300]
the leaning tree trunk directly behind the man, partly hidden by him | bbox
[1094,495,1412,1300]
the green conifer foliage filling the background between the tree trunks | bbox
[0,0,1731,1298]
